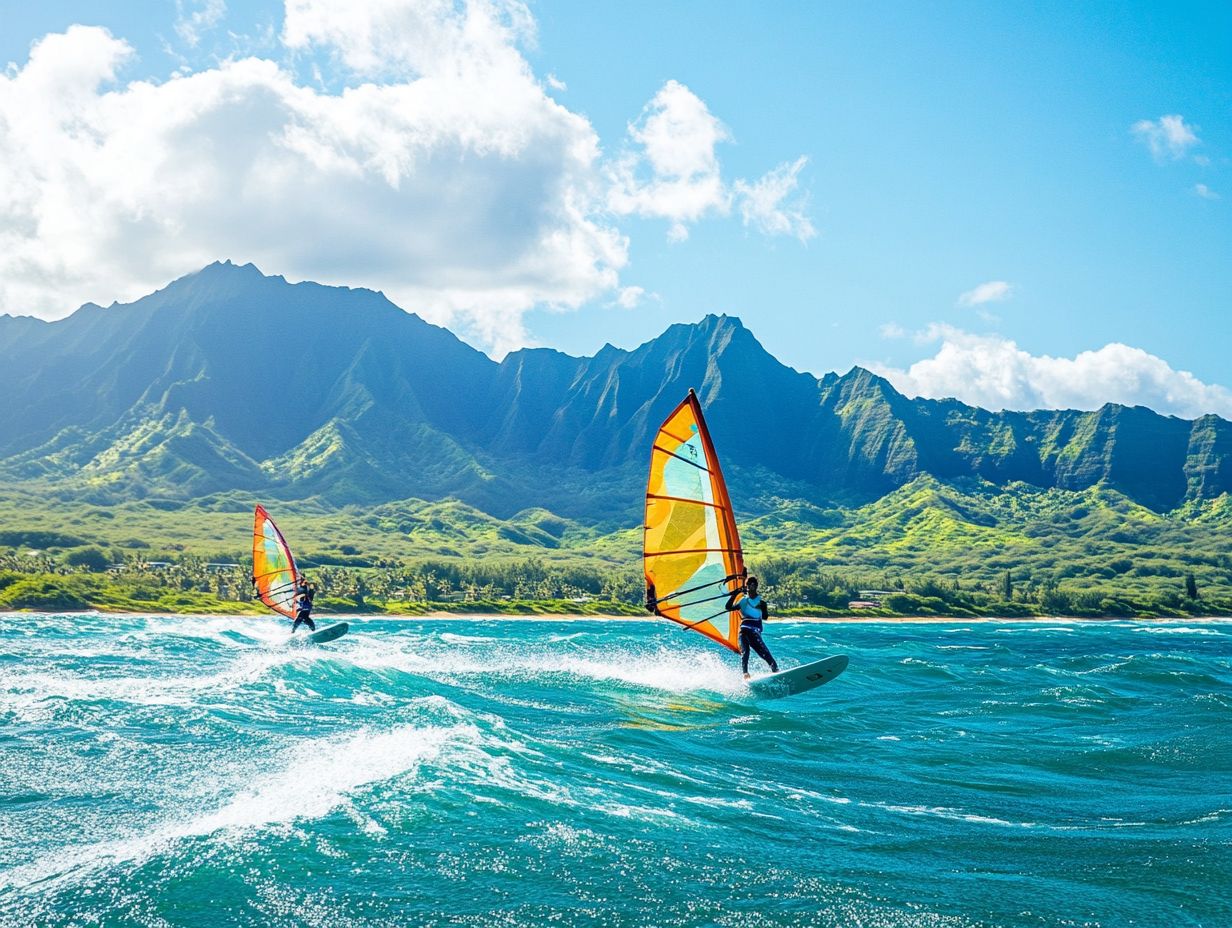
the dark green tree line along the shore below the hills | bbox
[0,547,1232,617]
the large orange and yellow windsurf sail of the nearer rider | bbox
[643,391,744,651]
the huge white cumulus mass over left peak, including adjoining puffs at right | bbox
[0,0,811,352]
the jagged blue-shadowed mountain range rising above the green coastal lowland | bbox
[0,263,1232,520]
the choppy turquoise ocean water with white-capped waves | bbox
[0,615,1232,928]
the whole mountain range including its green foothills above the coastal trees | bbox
[0,264,1232,611]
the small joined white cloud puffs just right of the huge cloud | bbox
[607,80,816,242]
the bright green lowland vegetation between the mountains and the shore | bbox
[0,477,1232,617]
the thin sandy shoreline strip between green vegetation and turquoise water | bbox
[0,609,1232,625]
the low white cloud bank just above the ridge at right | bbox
[870,325,1232,418]
